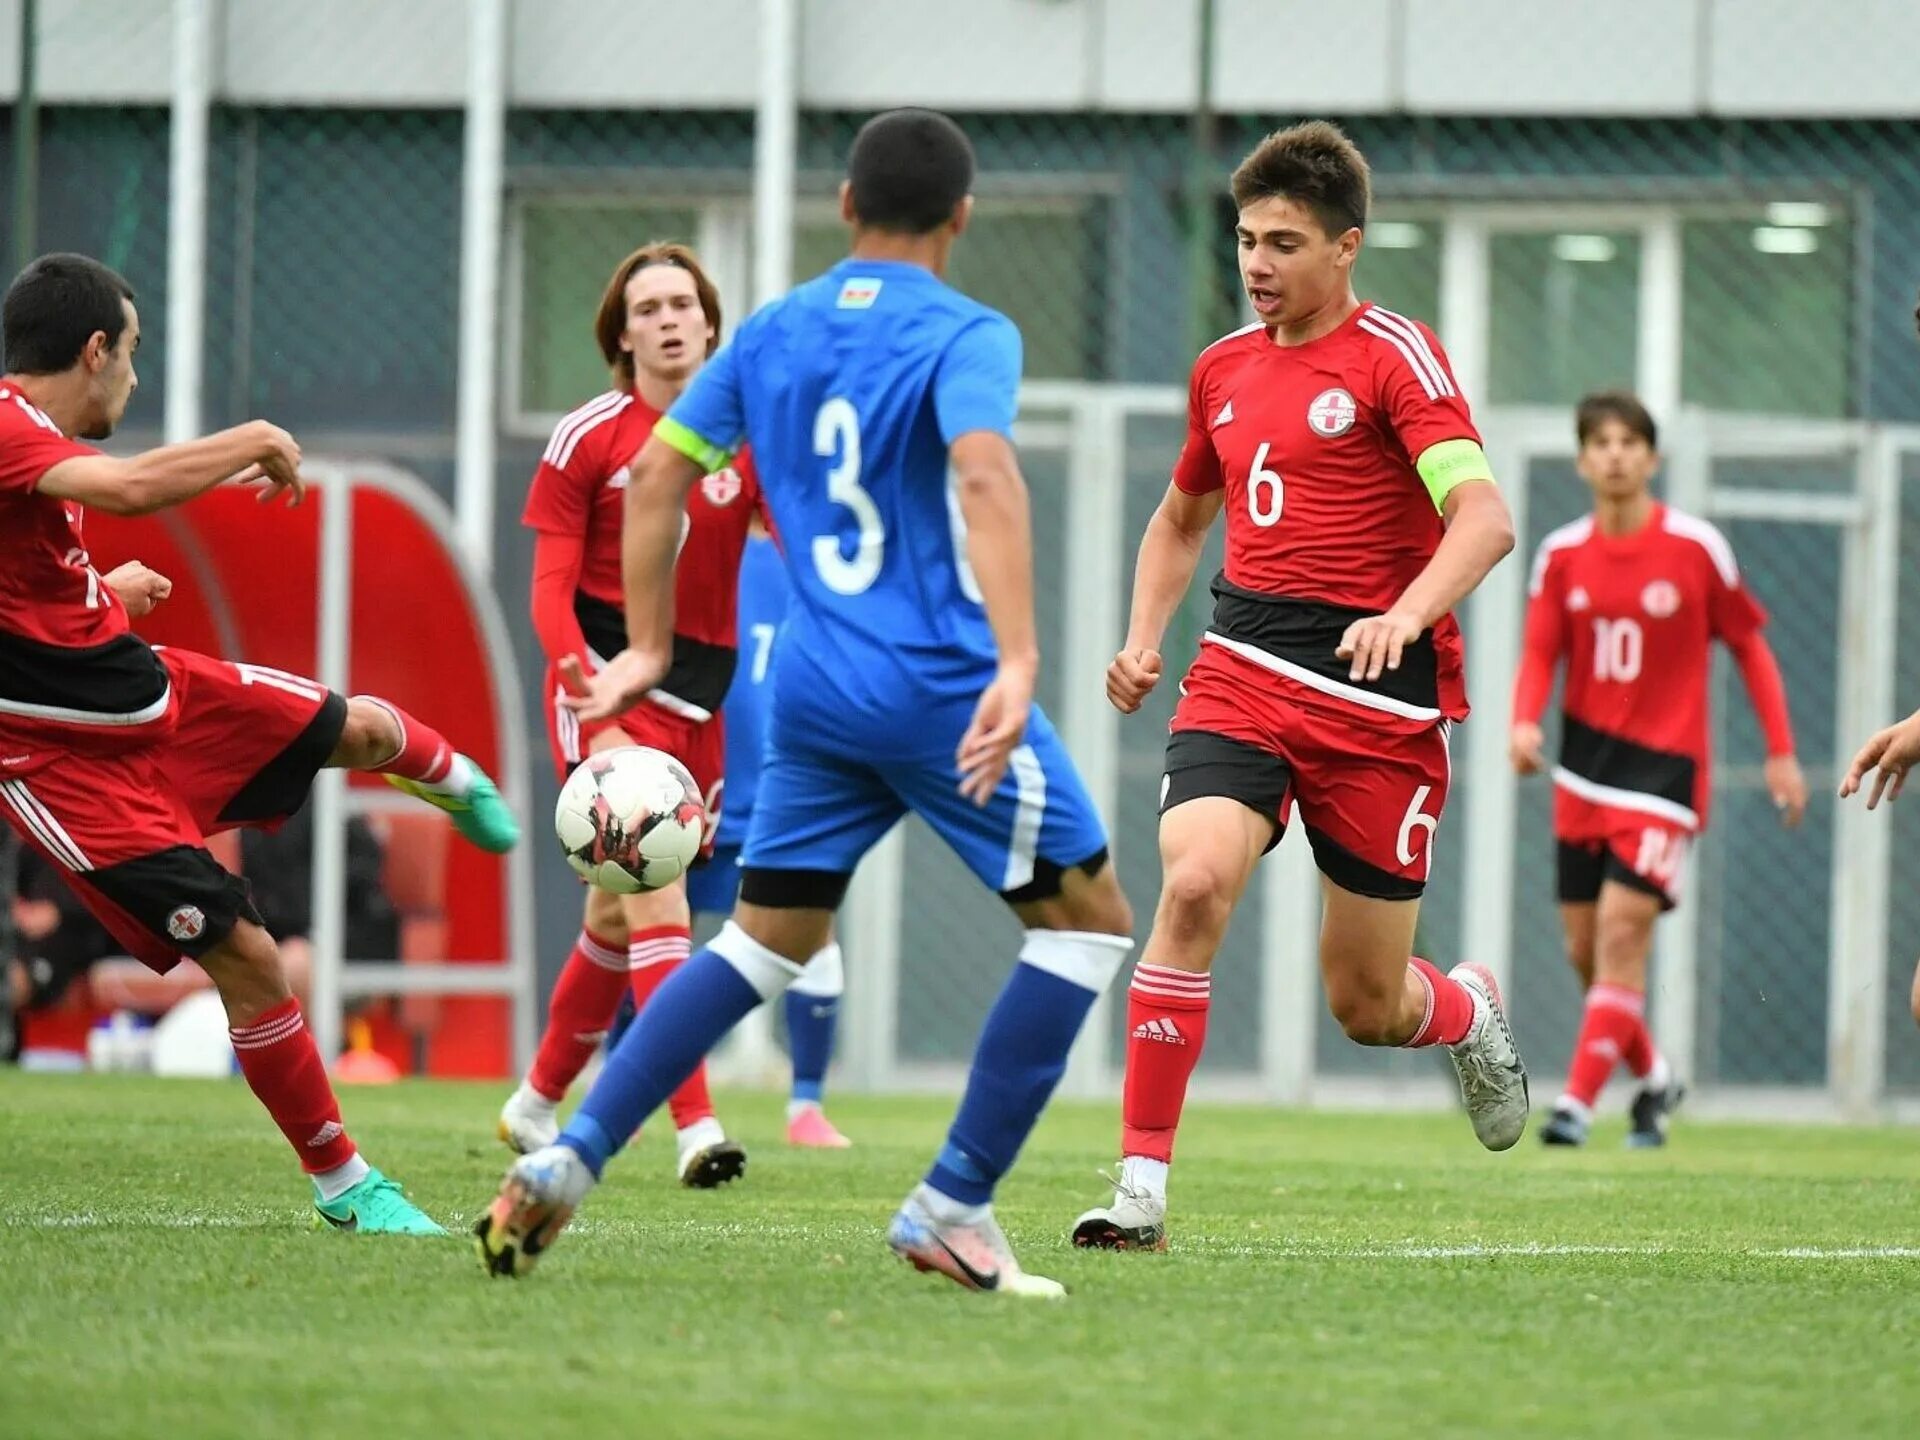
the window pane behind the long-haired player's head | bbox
[515,200,699,415]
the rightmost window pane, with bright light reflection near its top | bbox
[1680,211,1853,415]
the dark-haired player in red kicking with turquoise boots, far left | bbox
[0,255,518,1235]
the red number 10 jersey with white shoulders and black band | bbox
[1517,505,1766,829]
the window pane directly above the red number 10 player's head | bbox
[1488,230,1640,405]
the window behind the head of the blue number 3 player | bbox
[793,194,1110,380]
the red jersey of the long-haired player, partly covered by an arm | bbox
[520,390,762,712]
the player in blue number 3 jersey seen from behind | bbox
[478,109,1133,1296]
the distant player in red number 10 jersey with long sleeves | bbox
[1511,390,1807,1146]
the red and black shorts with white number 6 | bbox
[1160,645,1452,900]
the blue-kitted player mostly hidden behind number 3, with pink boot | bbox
[687,526,852,1150]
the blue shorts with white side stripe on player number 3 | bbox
[741,699,1106,895]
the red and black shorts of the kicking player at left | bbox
[0,647,348,972]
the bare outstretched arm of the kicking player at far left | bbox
[38,420,307,515]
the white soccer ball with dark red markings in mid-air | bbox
[553,745,707,895]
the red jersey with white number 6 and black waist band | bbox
[1173,305,1480,720]
